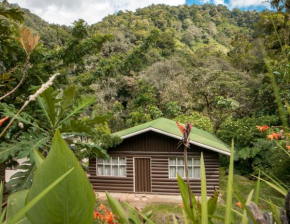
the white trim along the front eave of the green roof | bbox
[116,127,231,156]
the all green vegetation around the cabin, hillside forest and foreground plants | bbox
[0,1,290,224]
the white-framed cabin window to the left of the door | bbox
[97,157,126,177]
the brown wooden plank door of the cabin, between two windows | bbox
[134,158,151,192]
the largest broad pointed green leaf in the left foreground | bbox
[26,131,95,224]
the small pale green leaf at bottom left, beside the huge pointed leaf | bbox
[6,190,31,224]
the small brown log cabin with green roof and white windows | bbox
[89,118,230,195]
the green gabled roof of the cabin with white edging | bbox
[114,118,231,155]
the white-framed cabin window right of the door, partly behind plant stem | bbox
[169,158,200,179]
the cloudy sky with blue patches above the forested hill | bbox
[8,0,269,25]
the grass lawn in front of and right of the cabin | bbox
[143,168,284,223]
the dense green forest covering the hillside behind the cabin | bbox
[0,0,290,191]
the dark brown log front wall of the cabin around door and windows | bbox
[89,131,219,195]
